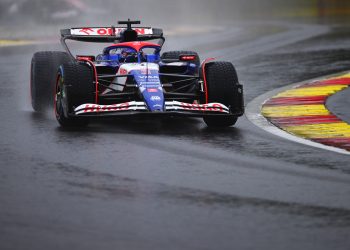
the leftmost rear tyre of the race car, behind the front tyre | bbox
[30,51,71,112]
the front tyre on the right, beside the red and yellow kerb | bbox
[203,62,238,127]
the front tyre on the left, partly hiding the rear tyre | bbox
[55,62,95,127]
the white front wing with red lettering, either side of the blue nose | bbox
[72,101,240,117]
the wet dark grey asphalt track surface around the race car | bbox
[0,23,350,250]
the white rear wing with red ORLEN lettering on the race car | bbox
[61,19,165,58]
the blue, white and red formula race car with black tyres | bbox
[30,20,244,127]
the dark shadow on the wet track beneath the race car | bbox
[30,112,247,149]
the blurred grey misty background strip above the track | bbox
[0,0,350,38]
